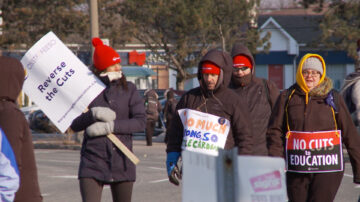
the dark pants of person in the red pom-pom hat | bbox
[79,178,134,202]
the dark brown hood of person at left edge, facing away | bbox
[0,56,25,102]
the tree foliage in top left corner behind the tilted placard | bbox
[0,0,90,49]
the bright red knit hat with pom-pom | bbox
[92,37,121,71]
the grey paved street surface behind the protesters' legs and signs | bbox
[35,140,360,202]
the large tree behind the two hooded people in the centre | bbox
[120,0,269,89]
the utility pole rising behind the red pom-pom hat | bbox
[89,0,99,64]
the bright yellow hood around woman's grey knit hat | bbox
[296,53,326,103]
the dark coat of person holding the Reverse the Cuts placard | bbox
[71,77,146,183]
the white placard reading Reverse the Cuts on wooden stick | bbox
[21,32,105,132]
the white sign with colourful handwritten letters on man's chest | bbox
[178,109,230,156]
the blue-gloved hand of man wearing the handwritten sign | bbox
[166,152,182,185]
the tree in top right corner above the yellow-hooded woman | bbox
[320,0,360,68]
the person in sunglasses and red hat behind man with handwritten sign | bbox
[230,44,280,156]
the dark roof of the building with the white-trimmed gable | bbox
[258,15,322,44]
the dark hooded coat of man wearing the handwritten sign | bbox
[166,50,253,154]
